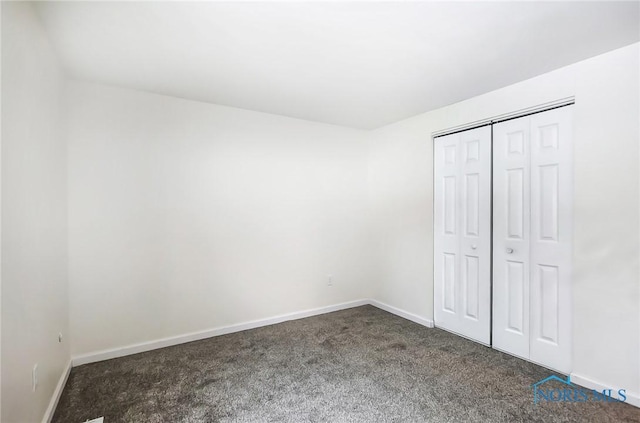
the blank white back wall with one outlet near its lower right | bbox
[67,82,371,355]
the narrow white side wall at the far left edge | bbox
[0,2,69,423]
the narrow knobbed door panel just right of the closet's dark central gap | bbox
[493,117,530,359]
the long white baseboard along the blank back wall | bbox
[72,299,370,367]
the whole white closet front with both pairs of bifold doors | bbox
[434,106,573,373]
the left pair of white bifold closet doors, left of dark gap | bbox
[434,126,491,344]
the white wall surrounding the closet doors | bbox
[369,44,640,395]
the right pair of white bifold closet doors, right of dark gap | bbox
[493,107,573,372]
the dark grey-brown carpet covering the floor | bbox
[53,306,640,423]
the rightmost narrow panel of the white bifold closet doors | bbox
[530,107,573,373]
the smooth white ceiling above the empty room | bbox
[37,1,640,129]
